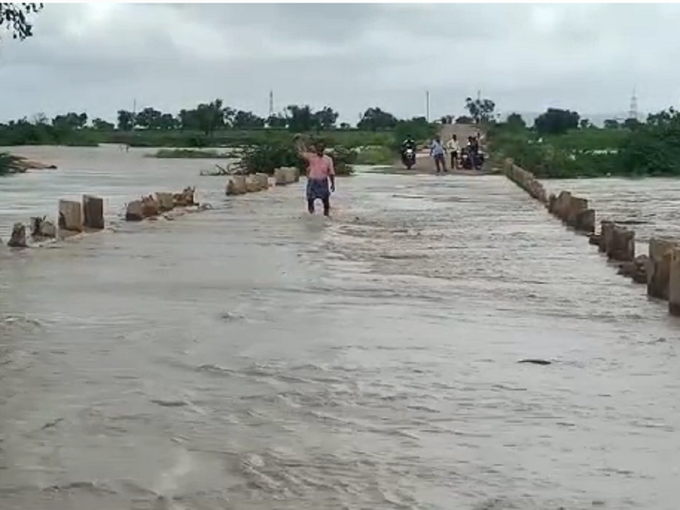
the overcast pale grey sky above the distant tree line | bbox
[0,4,680,122]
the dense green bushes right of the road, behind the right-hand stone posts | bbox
[489,108,680,178]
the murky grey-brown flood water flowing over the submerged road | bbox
[0,145,680,510]
